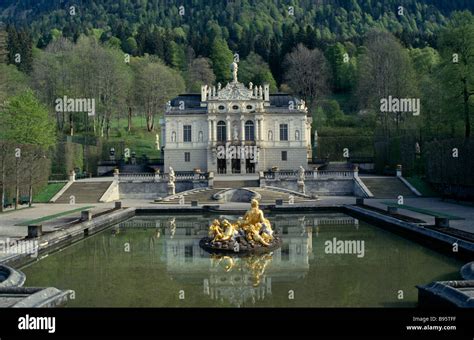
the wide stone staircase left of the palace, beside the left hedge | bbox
[55,181,112,203]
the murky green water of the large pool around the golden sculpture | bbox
[22,214,463,307]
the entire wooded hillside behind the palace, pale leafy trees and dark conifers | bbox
[0,0,474,199]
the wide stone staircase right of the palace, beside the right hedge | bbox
[360,177,417,198]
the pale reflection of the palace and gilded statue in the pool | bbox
[143,216,314,307]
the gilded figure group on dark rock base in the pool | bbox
[201,199,281,253]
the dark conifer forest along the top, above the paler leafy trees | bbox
[0,0,474,83]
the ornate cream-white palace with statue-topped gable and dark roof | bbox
[161,62,312,174]
